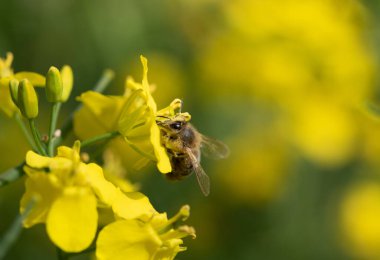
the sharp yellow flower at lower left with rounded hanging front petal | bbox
[21,141,156,252]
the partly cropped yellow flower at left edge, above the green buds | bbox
[0,52,45,117]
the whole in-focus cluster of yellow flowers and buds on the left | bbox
[0,54,195,259]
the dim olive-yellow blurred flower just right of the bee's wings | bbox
[215,126,291,206]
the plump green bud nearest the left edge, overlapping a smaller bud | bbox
[18,79,38,119]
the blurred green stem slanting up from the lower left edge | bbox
[0,199,36,259]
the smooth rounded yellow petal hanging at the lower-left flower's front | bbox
[46,187,98,252]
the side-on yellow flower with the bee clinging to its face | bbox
[74,56,171,173]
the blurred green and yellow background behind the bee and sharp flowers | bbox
[0,0,380,259]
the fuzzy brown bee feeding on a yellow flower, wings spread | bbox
[157,114,229,196]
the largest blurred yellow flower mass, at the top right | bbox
[200,0,374,105]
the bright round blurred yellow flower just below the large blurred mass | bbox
[287,97,362,167]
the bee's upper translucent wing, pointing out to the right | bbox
[201,135,230,159]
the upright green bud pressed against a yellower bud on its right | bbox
[45,66,63,103]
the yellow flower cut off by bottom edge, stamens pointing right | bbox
[96,206,195,260]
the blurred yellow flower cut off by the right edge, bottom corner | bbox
[340,182,380,259]
